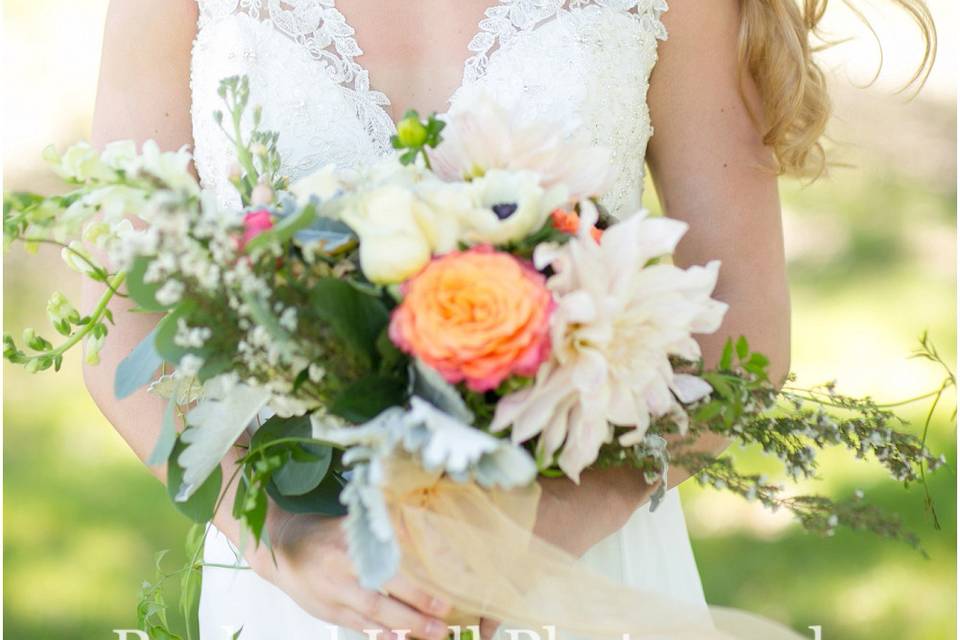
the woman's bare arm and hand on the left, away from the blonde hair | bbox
[83,0,447,640]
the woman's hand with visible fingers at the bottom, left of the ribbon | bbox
[250,515,450,640]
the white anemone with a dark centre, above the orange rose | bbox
[463,169,566,244]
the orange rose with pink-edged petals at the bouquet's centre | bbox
[390,246,553,391]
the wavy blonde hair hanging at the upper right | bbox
[739,0,937,179]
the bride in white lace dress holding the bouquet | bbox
[85,0,933,640]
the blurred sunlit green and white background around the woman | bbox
[3,0,957,640]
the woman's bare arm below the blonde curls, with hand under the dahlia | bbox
[538,0,790,553]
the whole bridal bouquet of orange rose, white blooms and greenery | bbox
[4,78,952,636]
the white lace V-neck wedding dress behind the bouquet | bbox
[192,0,706,640]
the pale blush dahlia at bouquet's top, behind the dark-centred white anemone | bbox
[429,87,611,200]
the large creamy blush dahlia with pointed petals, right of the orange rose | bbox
[491,206,727,480]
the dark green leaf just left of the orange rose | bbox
[310,278,390,367]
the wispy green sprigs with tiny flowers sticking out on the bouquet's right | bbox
[597,335,956,548]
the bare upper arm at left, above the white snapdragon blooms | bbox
[93,0,198,148]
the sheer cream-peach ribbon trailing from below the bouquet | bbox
[383,456,805,640]
